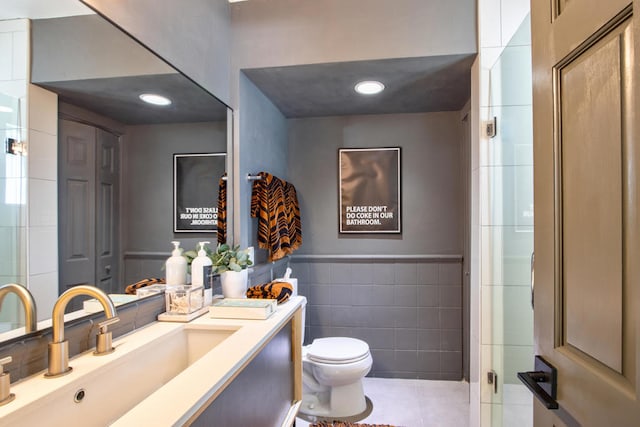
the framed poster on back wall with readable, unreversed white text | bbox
[338,147,402,233]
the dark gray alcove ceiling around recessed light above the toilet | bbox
[243,54,475,118]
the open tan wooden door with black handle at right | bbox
[531,0,640,427]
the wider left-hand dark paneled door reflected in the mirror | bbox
[58,120,96,293]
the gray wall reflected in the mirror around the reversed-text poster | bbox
[121,122,227,284]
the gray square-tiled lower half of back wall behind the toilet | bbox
[290,255,464,380]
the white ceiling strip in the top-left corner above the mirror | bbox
[0,0,94,20]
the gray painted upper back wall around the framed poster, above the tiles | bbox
[289,112,464,255]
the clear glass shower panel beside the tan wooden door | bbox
[482,16,533,427]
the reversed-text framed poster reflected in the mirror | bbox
[173,153,227,233]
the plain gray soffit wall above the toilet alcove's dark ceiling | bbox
[231,0,476,69]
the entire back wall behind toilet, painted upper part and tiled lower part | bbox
[288,112,468,380]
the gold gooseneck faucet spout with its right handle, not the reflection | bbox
[44,285,119,378]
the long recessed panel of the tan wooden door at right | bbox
[556,21,629,372]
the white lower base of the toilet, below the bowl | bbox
[300,381,367,418]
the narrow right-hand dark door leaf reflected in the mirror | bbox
[96,129,120,293]
